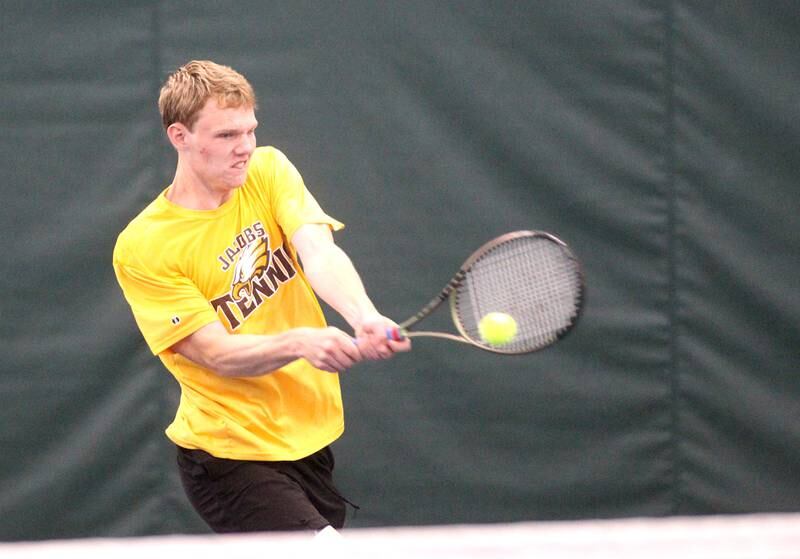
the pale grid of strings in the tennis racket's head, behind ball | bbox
[453,237,582,353]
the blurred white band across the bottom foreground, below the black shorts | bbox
[0,514,800,559]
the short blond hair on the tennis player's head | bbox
[158,60,256,130]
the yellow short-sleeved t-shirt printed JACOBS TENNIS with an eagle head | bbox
[114,147,344,460]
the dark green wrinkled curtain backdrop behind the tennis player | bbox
[0,0,800,540]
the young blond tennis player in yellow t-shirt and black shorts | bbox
[114,61,410,532]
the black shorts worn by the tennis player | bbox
[178,447,348,533]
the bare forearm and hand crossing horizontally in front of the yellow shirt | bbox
[172,322,362,377]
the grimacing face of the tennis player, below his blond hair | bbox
[181,99,258,196]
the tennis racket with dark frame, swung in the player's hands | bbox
[386,231,584,354]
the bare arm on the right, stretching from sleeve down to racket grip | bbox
[291,223,411,359]
